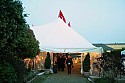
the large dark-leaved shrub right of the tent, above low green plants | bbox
[101,50,123,76]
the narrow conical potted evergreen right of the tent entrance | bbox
[83,53,90,72]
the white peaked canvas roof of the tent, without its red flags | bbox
[31,18,102,53]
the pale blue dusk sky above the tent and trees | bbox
[22,0,125,43]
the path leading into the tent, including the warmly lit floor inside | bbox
[43,63,89,83]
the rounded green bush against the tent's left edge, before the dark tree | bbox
[15,29,39,59]
